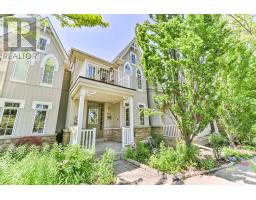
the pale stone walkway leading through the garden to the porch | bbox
[115,160,170,185]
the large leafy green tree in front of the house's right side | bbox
[136,15,248,146]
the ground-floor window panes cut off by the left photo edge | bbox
[0,102,20,136]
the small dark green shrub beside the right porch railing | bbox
[124,142,151,163]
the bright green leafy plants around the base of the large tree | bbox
[148,143,199,174]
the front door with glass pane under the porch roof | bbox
[86,102,104,138]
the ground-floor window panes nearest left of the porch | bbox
[32,104,49,134]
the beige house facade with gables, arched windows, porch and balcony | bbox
[0,18,212,149]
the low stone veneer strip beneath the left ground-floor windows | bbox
[0,135,56,149]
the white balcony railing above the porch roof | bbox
[84,64,131,88]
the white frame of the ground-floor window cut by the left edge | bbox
[0,98,25,138]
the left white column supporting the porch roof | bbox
[76,89,86,144]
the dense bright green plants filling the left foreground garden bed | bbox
[0,144,115,185]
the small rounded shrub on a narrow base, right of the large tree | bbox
[209,133,228,160]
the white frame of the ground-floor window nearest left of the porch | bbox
[31,101,52,135]
